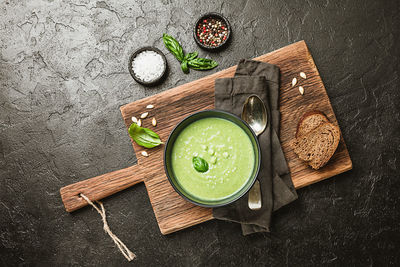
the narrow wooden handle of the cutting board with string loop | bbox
[60,164,145,212]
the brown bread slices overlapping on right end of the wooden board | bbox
[291,111,340,170]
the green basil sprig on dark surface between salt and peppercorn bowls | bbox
[163,33,218,73]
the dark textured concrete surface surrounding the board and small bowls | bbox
[0,0,400,266]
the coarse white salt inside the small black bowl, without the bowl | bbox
[132,51,165,82]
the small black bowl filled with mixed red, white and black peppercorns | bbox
[193,12,231,51]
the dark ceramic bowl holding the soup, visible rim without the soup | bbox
[164,110,261,208]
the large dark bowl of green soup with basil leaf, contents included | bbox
[164,110,261,207]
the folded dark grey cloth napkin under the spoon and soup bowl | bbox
[213,59,297,235]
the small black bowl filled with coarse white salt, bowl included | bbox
[129,46,167,86]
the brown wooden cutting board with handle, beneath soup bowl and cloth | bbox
[60,41,352,234]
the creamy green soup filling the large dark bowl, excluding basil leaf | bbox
[171,117,255,200]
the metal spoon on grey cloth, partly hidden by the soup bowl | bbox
[242,95,268,210]
